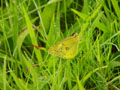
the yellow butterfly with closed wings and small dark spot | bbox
[48,33,79,59]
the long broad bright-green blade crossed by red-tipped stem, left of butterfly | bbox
[22,6,42,63]
